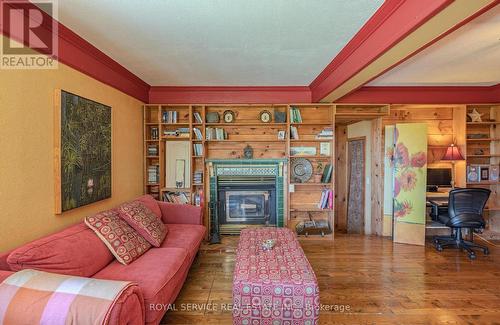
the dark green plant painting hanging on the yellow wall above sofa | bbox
[54,89,112,214]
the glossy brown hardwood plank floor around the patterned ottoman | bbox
[162,234,500,325]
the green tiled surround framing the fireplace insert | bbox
[207,159,287,242]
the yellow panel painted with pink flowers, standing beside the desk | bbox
[386,123,427,223]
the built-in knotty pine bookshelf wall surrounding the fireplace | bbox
[144,104,335,239]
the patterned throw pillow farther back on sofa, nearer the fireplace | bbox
[118,201,168,247]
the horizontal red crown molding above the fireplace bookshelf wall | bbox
[149,86,311,104]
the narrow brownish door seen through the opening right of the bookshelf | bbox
[347,137,366,234]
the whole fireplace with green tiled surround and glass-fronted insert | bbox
[208,159,285,243]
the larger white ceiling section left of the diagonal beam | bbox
[55,0,383,86]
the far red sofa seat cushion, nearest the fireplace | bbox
[161,224,206,259]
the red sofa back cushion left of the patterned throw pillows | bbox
[7,222,113,277]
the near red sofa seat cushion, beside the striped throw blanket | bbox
[94,248,191,324]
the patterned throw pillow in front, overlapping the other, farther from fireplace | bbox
[85,210,151,265]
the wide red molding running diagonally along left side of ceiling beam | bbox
[310,0,453,102]
